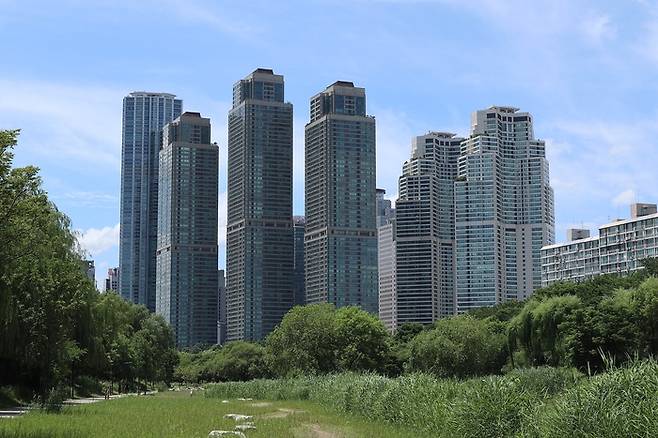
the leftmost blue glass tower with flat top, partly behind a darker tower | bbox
[119,92,183,311]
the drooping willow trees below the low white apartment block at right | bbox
[509,272,658,372]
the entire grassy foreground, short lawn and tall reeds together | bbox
[5,360,658,438]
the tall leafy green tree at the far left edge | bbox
[0,127,95,392]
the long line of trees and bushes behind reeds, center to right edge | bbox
[175,259,658,382]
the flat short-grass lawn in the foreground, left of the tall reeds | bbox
[0,392,419,438]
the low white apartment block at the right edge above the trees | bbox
[541,204,658,286]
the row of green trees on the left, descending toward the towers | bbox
[0,131,178,394]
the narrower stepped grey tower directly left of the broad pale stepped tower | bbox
[395,132,463,324]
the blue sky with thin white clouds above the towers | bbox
[0,0,658,281]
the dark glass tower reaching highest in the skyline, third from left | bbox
[226,68,294,341]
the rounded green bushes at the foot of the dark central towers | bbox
[175,304,390,382]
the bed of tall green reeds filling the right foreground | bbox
[206,360,658,438]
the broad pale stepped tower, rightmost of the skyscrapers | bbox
[455,107,555,313]
